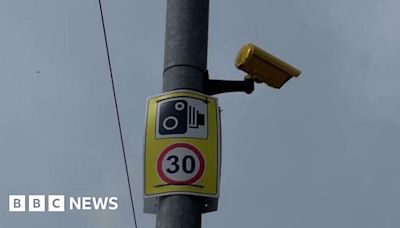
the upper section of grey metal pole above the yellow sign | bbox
[163,0,209,92]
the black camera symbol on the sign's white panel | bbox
[158,100,204,135]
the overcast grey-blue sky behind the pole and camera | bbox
[0,0,400,228]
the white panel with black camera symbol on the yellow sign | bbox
[156,97,208,139]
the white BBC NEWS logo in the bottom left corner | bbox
[8,195,118,212]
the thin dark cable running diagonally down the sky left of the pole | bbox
[99,0,138,228]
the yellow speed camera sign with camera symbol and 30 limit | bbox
[144,90,220,207]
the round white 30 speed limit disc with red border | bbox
[157,143,205,187]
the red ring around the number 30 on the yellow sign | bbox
[157,143,205,185]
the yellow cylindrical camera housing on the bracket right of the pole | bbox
[235,43,301,89]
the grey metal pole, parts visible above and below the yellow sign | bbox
[156,0,209,228]
